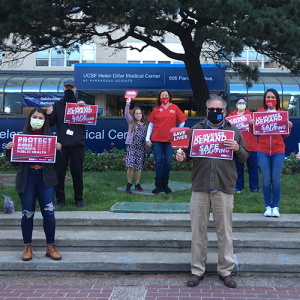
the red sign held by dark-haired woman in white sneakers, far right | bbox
[253,111,289,135]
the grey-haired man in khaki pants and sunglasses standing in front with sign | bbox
[176,95,249,288]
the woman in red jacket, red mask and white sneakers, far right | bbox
[257,89,293,218]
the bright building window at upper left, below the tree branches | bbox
[35,44,96,67]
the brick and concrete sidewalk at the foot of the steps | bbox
[0,274,300,300]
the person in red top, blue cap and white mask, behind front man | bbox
[228,97,259,194]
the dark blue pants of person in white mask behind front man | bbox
[235,151,259,190]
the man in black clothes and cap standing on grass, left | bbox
[47,80,85,208]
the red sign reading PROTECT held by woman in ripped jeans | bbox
[11,134,57,163]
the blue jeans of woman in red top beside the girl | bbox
[152,142,174,177]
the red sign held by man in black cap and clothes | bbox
[64,103,98,125]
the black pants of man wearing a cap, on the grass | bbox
[55,146,85,203]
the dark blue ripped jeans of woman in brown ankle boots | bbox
[19,168,55,244]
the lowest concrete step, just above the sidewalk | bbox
[0,251,300,277]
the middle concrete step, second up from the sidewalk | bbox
[0,229,300,252]
